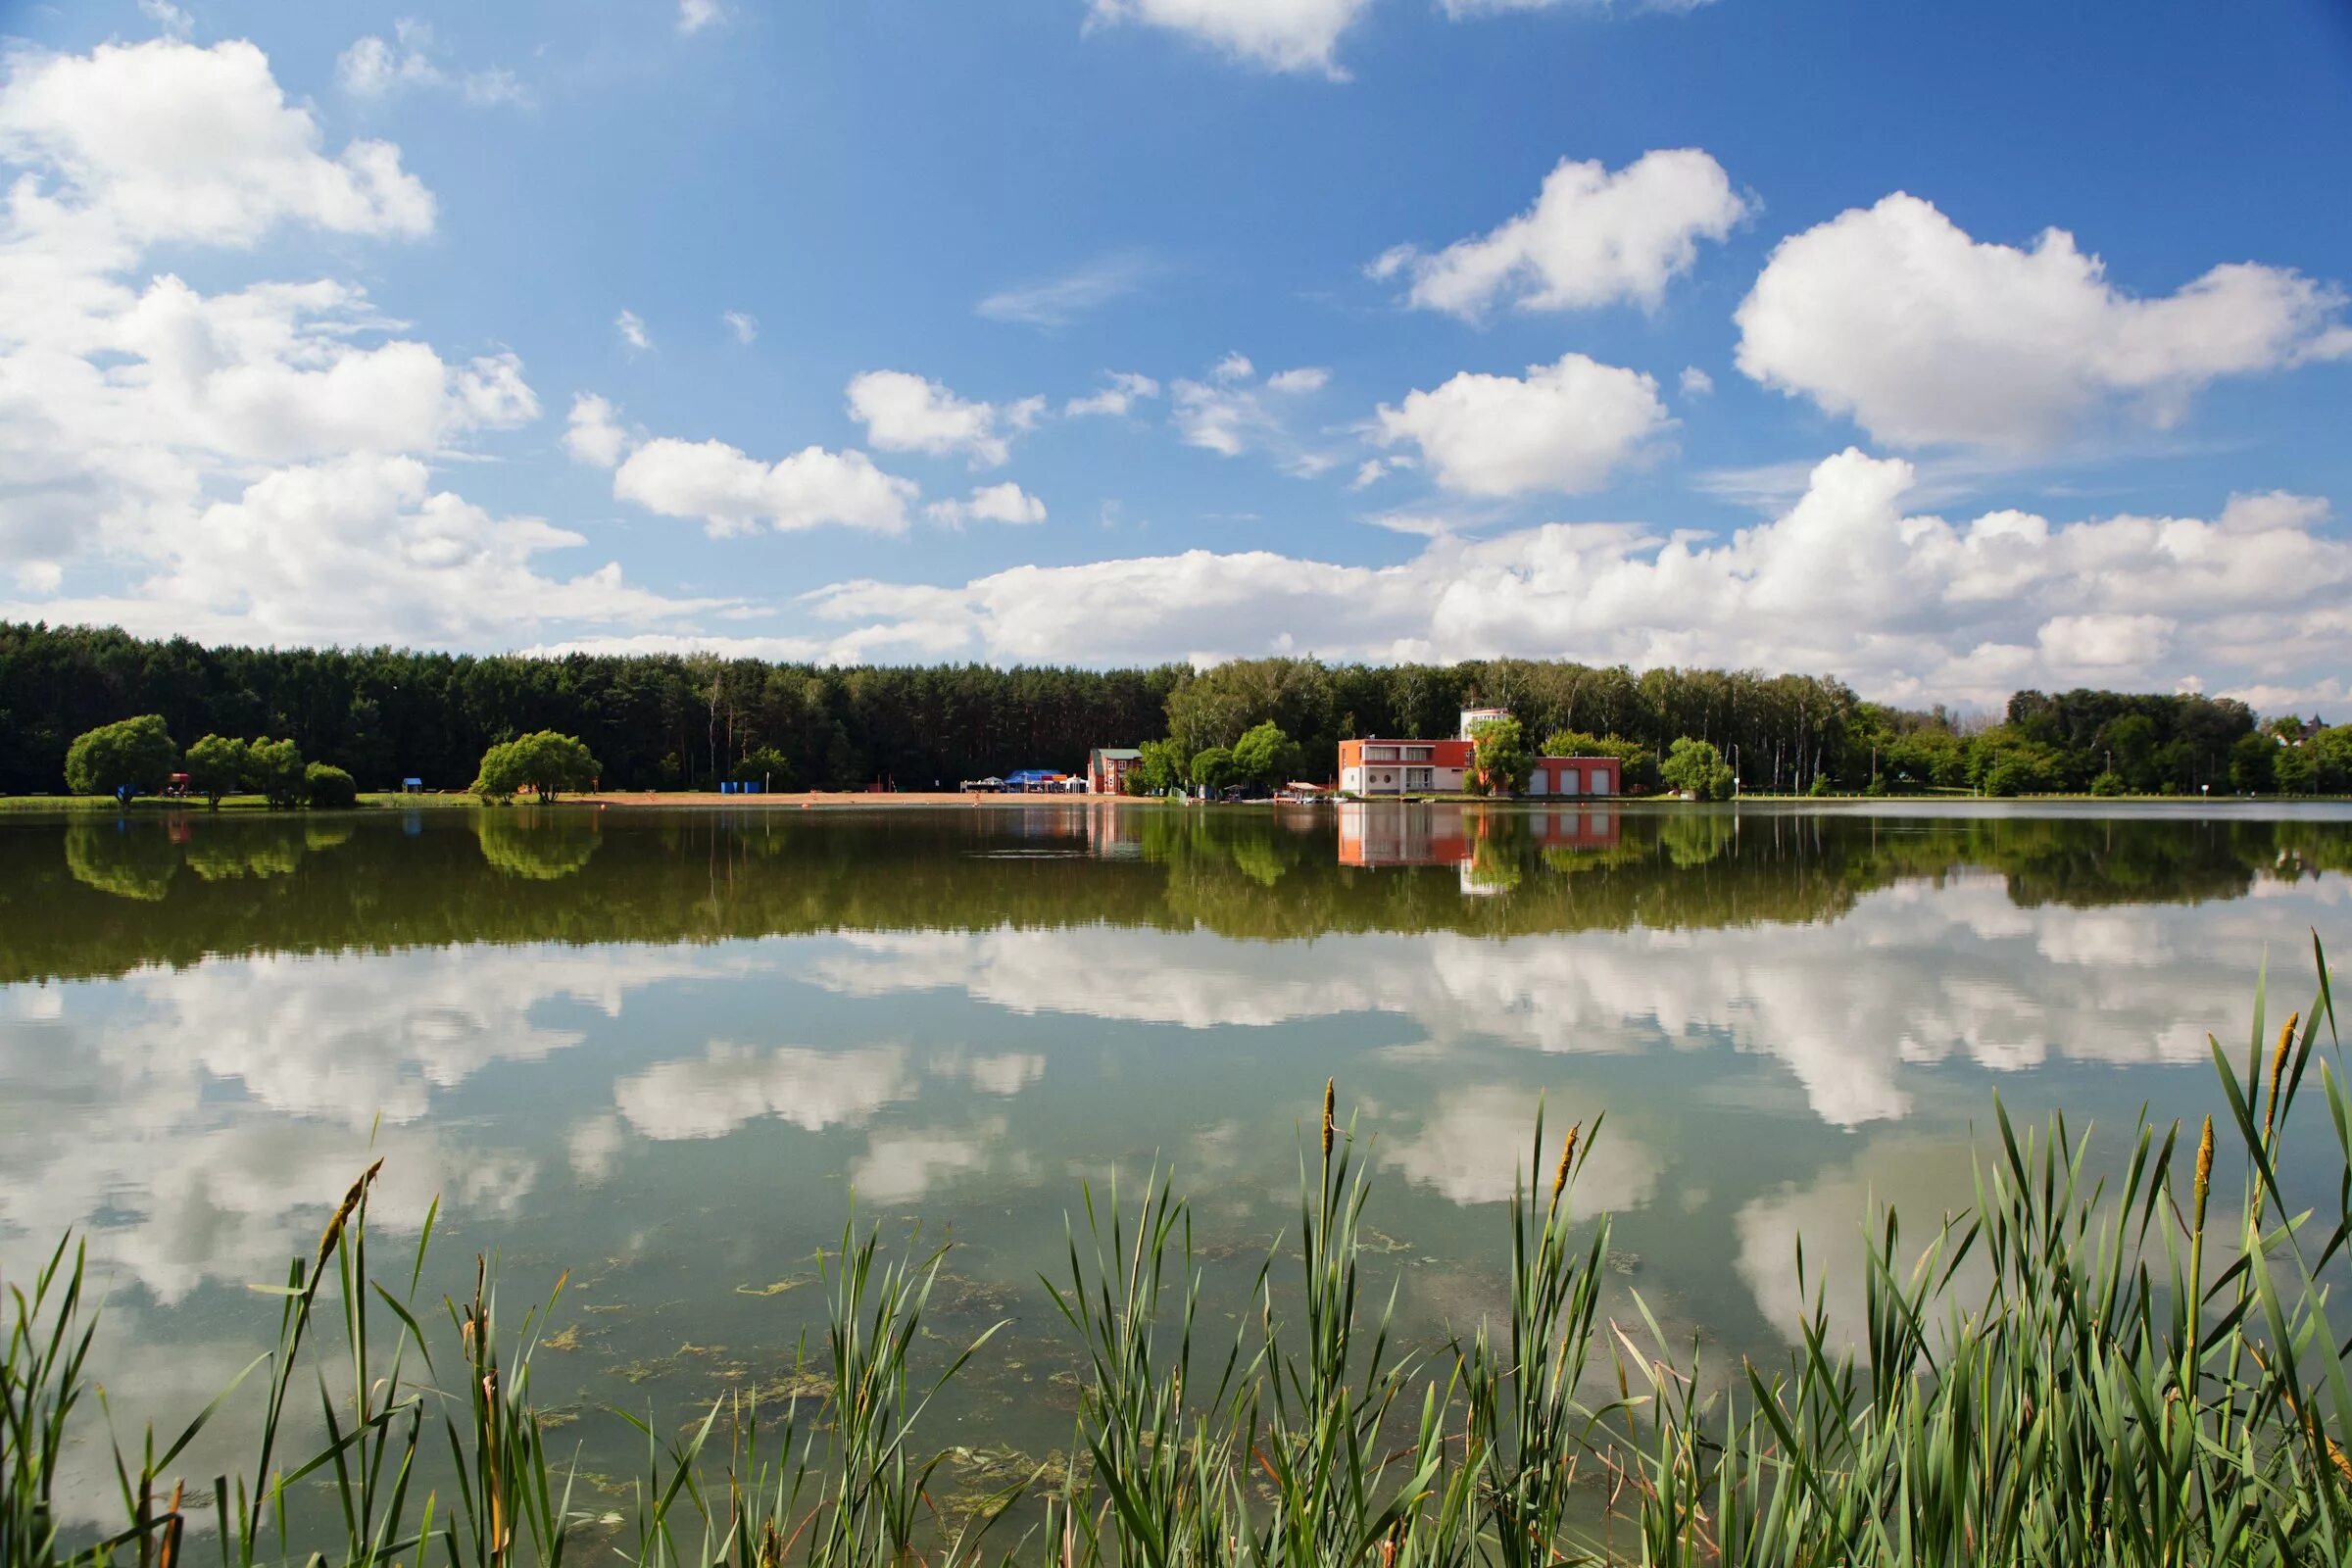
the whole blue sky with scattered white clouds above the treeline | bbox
[0,0,2352,708]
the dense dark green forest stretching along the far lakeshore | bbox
[0,623,2314,795]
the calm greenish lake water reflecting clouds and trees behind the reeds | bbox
[0,804,2352,1502]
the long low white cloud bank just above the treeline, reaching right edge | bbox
[785,452,2352,703]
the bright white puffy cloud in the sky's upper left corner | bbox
[0,37,433,245]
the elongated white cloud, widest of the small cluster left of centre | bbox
[615,437,919,534]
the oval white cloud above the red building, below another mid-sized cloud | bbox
[1378,353,1670,496]
